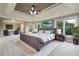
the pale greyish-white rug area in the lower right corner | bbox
[49,42,79,56]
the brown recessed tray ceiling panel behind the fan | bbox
[15,3,56,14]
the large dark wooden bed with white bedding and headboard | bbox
[20,28,56,51]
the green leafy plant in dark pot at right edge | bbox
[72,27,79,45]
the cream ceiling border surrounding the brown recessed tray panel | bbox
[0,3,79,22]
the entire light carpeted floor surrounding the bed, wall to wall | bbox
[0,36,79,56]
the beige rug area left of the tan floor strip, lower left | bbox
[0,41,27,56]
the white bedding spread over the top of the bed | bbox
[29,33,55,43]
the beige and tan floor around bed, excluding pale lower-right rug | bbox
[0,36,61,56]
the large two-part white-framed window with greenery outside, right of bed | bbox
[56,19,75,35]
